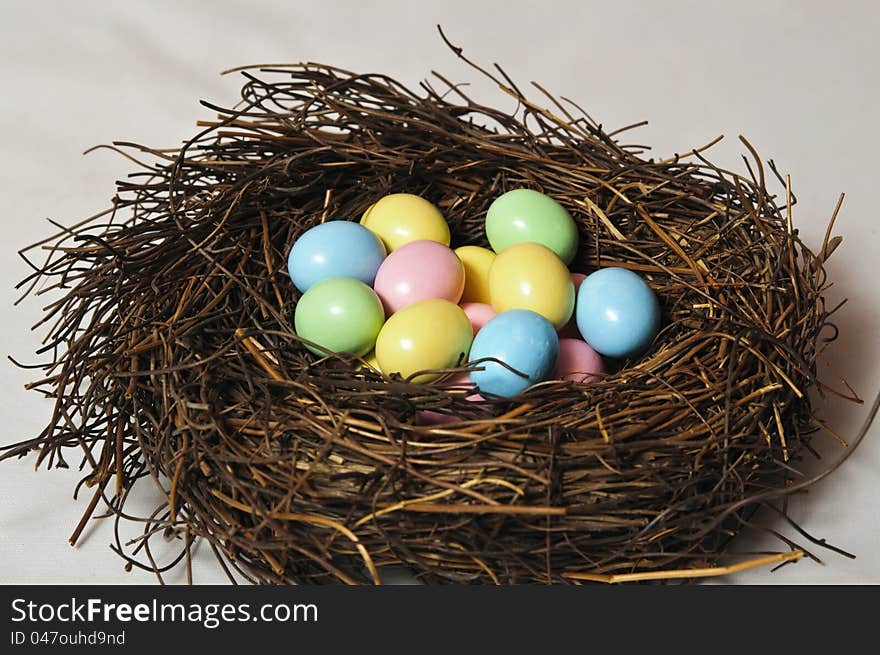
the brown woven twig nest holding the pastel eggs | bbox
[5,47,835,583]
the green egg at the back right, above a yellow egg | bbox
[486,189,578,264]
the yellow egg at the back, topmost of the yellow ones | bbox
[361,193,449,253]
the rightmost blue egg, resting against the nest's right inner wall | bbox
[575,268,660,357]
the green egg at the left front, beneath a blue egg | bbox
[293,277,384,355]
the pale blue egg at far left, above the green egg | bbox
[287,221,385,293]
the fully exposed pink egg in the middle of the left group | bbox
[373,241,464,314]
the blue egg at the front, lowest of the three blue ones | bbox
[469,309,559,398]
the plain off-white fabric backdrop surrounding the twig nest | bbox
[0,0,880,583]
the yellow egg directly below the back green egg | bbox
[489,243,575,328]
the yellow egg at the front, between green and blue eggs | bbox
[376,299,473,384]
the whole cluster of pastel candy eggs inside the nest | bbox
[288,189,660,397]
